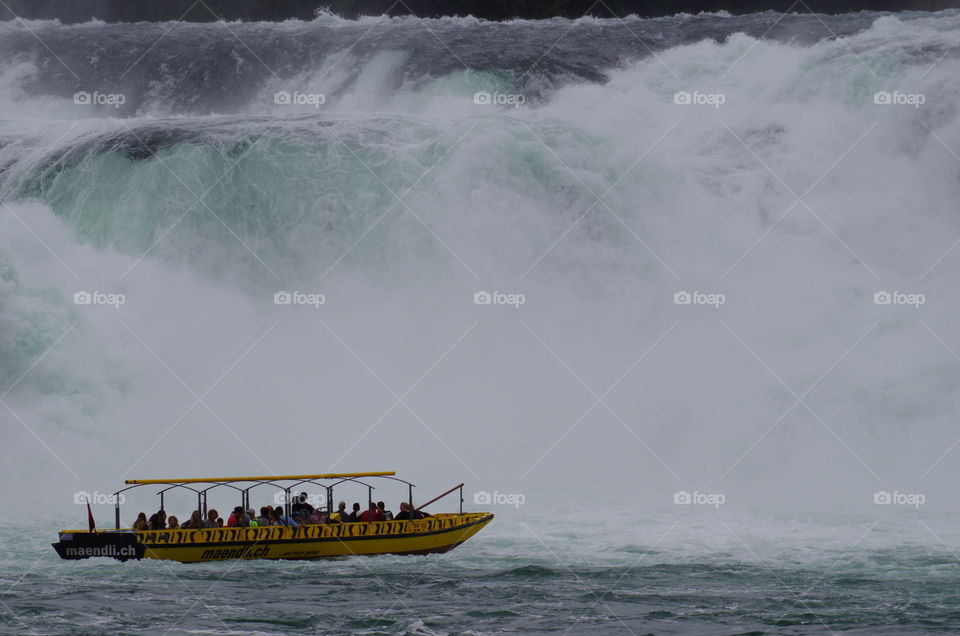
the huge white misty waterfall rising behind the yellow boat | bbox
[0,12,960,629]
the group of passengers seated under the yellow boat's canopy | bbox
[133,492,430,530]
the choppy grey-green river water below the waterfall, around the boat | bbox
[0,512,960,634]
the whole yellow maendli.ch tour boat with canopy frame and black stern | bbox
[53,472,493,563]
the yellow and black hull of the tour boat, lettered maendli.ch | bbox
[53,512,493,563]
